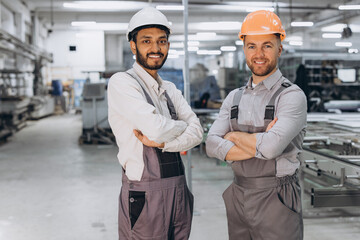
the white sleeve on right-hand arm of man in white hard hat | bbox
[163,83,203,152]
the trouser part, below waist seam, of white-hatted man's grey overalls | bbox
[119,176,194,240]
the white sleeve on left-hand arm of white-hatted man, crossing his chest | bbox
[108,73,187,143]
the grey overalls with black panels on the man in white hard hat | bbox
[119,70,193,240]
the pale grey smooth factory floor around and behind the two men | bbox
[0,114,360,240]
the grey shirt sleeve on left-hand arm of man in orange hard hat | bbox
[206,90,236,160]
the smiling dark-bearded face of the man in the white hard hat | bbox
[130,28,170,77]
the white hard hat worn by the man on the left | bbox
[126,7,171,41]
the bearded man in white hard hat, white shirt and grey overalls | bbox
[108,7,203,240]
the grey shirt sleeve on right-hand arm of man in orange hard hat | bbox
[255,86,307,160]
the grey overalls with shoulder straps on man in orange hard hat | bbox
[223,82,303,240]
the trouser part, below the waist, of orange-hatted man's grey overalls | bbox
[223,175,303,240]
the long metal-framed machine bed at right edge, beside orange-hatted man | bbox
[301,113,360,211]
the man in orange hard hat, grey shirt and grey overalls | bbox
[206,10,306,240]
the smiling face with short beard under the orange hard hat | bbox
[244,34,282,84]
